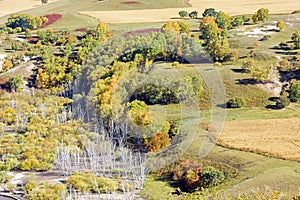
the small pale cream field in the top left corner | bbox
[0,0,58,17]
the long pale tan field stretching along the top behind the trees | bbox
[80,0,300,23]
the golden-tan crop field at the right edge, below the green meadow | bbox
[218,118,300,161]
